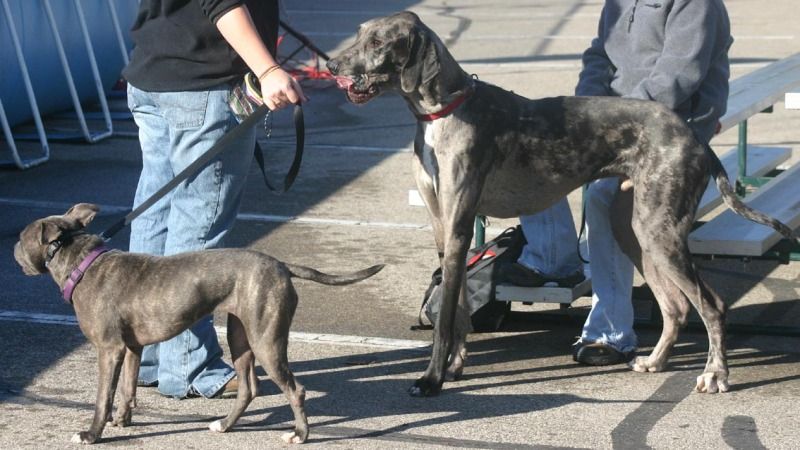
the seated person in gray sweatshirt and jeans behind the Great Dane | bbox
[506,0,732,365]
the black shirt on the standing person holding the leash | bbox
[122,0,278,92]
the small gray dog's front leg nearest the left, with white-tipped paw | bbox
[72,344,126,444]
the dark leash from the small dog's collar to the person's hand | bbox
[100,104,305,241]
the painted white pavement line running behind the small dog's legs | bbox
[0,310,431,350]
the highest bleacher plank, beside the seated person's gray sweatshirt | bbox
[720,53,800,131]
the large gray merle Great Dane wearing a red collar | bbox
[328,12,792,396]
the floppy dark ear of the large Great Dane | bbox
[400,23,439,93]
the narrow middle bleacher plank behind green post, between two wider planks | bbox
[696,145,792,219]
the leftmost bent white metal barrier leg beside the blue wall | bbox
[0,0,50,169]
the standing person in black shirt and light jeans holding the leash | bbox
[123,0,305,398]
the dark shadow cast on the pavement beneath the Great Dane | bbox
[220,331,664,442]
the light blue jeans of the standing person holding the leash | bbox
[128,85,255,398]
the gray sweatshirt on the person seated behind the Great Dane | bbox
[575,0,733,142]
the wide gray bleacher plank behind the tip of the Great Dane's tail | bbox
[689,164,800,256]
